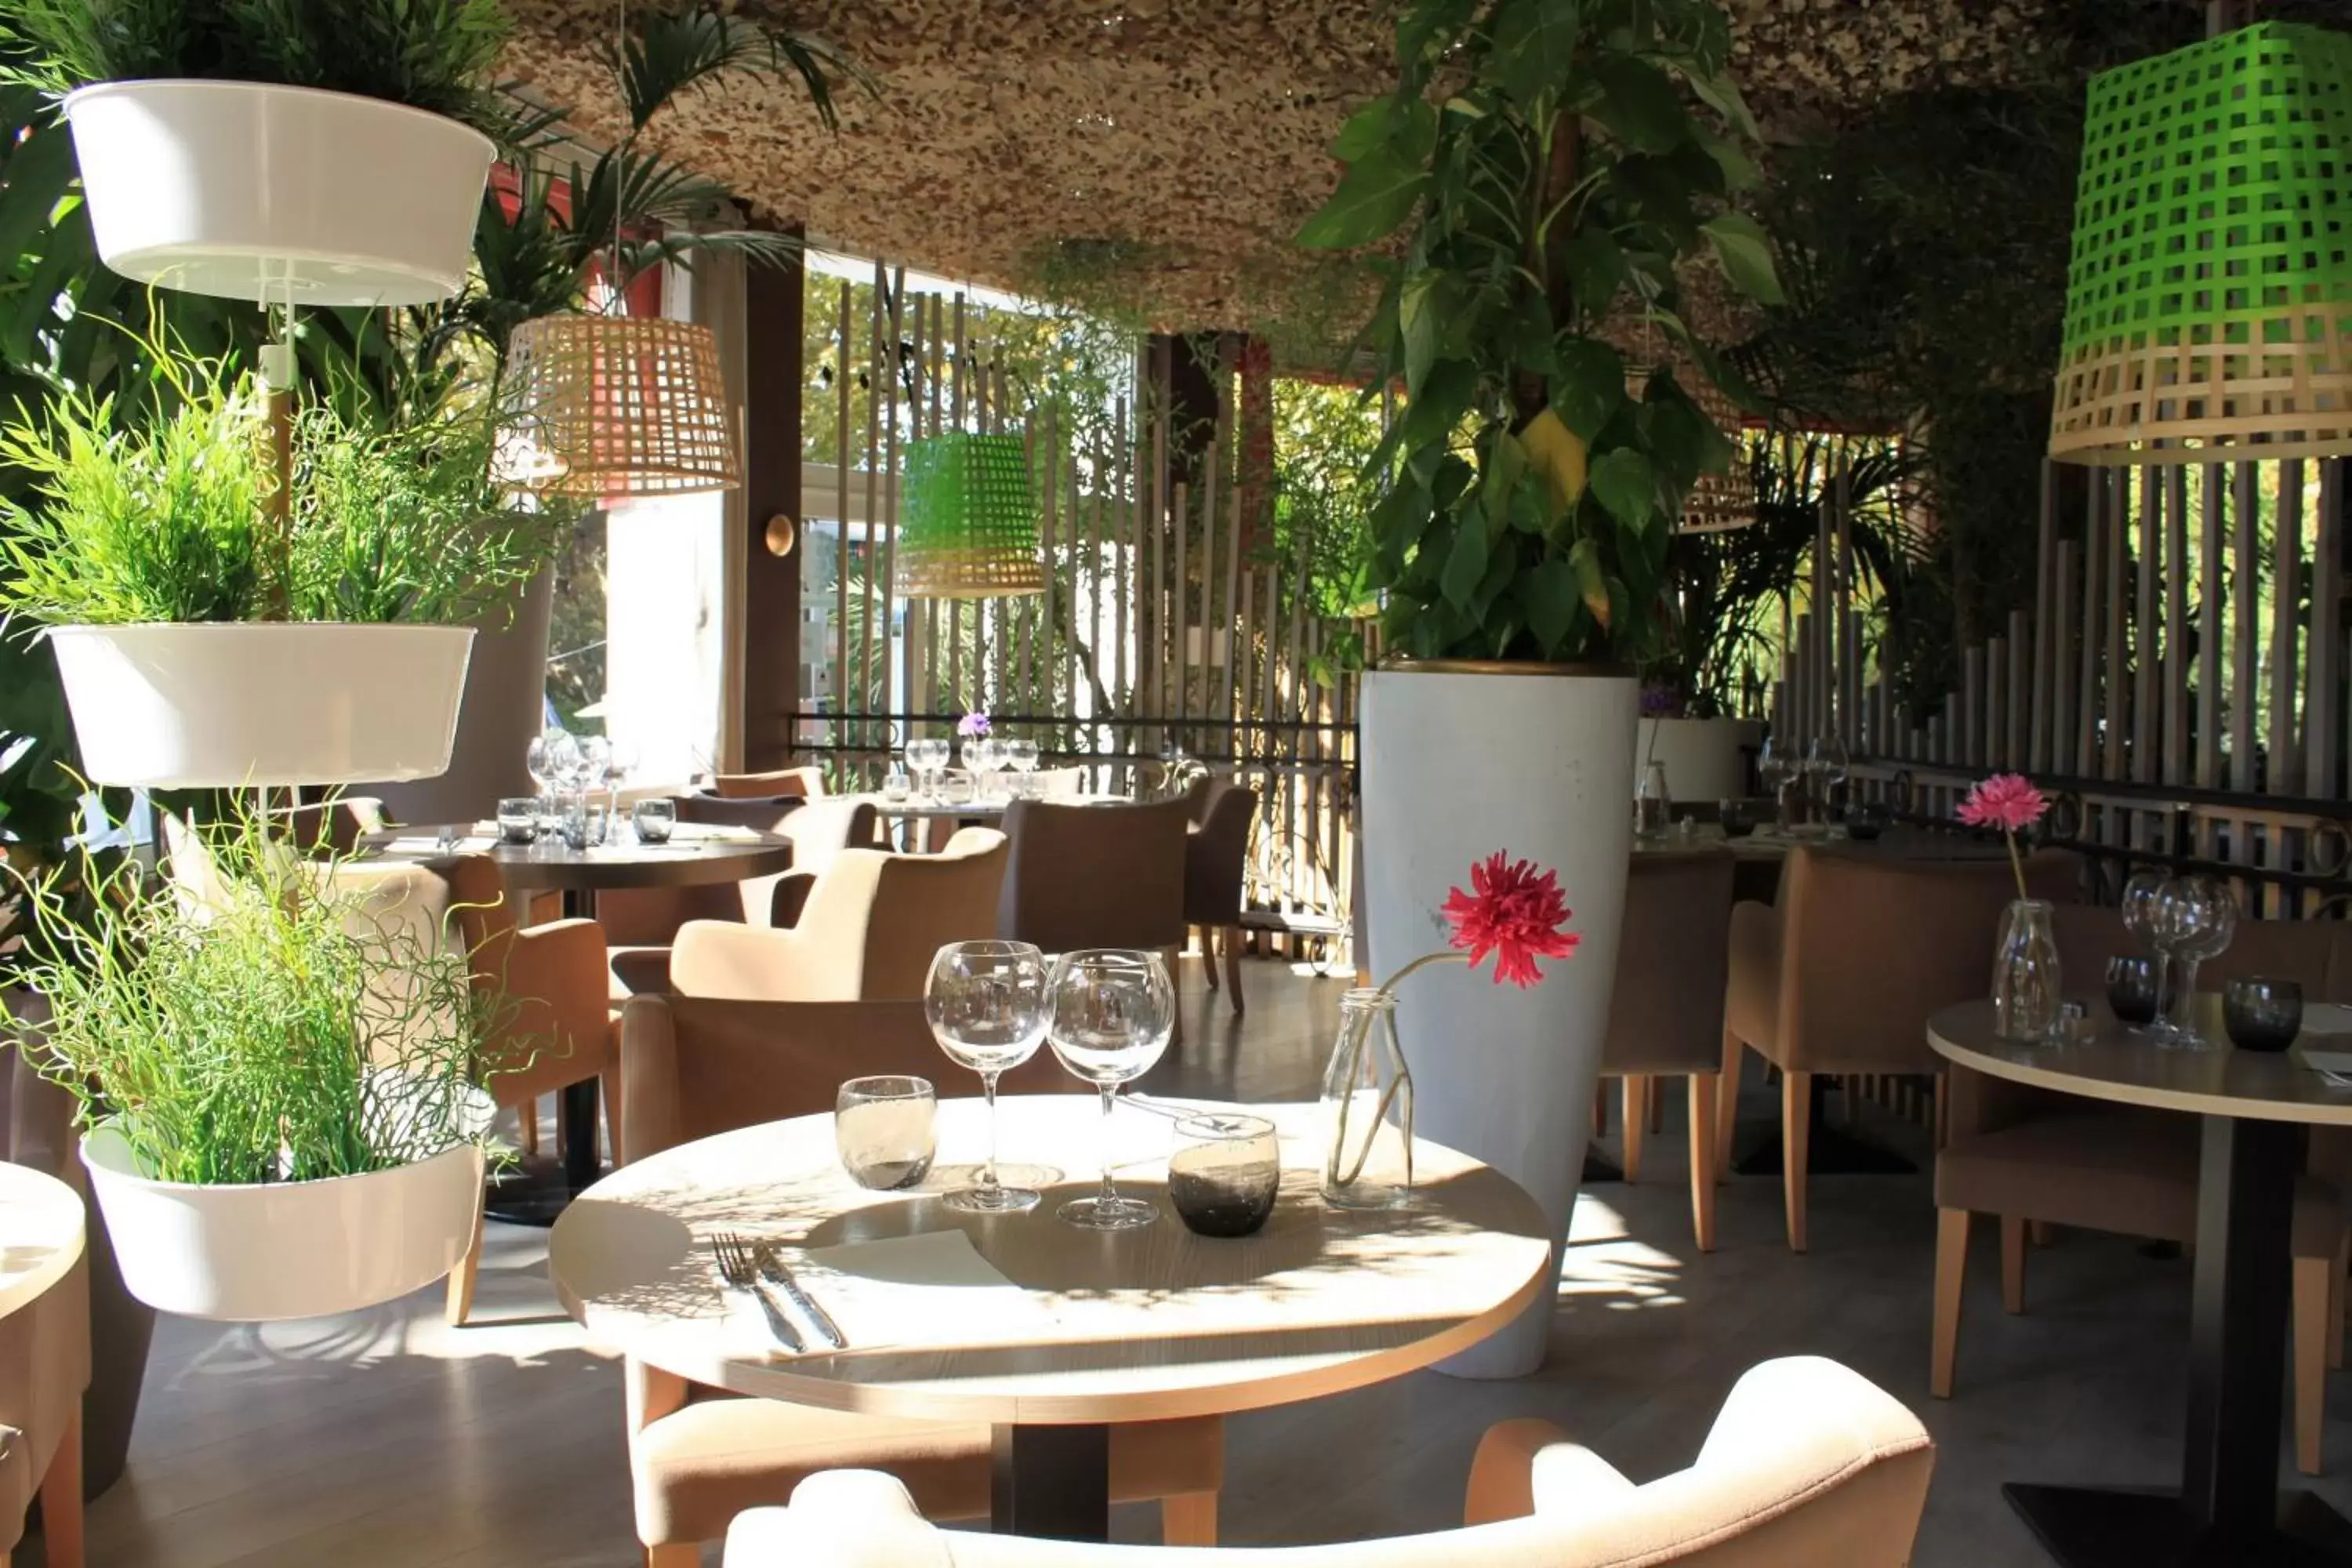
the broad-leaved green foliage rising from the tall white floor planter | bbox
[1298,0,1778,663]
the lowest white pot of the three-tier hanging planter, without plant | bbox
[82,1128,482,1323]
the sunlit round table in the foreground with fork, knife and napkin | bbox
[548,1095,1555,1540]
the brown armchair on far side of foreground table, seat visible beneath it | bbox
[621,996,1225,1568]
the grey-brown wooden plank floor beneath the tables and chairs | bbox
[41,961,2352,1568]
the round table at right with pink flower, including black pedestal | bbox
[1926,1001,2352,1568]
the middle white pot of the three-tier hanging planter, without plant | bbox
[49,621,473,789]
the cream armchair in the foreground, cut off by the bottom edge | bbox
[727,1356,1933,1568]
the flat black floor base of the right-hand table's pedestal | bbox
[2002,1481,2352,1568]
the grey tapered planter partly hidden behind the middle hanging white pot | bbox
[369,567,555,822]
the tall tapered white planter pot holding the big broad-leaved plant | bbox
[1359,666,1637,1377]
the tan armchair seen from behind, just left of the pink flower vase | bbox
[1715,846,2074,1253]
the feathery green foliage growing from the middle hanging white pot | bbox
[0,333,569,626]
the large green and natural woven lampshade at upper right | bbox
[2051,21,2352,463]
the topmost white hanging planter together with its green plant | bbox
[0,0,508,306]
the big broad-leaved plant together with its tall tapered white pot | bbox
[1298,0,1776,1375]
